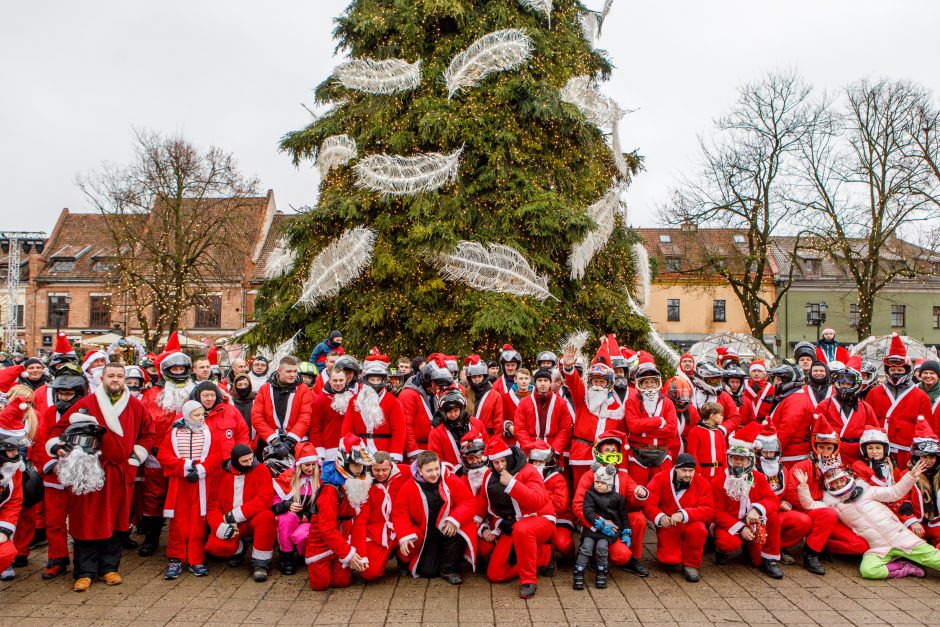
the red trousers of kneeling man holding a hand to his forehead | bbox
[486,516,555,585]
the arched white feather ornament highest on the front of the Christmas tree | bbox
[444,28,532,99]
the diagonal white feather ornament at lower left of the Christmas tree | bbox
[295,226,375,309]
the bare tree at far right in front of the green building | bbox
[801,80,940,340]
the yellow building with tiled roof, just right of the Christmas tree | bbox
[635,225,777,349]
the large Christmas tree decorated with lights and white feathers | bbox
[249,0,664,355]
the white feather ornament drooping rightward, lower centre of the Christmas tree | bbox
[434,240,557,300]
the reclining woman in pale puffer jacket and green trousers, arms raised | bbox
[793,461,940,579]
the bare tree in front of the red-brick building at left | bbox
[78,131,258,350]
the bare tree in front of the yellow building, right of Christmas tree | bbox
[661,72,827,348]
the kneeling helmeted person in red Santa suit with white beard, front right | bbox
[711,439,783,579]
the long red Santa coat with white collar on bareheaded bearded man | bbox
[46,386,153,540]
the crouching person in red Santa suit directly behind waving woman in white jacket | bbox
[782,414,868,556]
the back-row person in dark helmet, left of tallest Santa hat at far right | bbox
[816,355,878,466]
